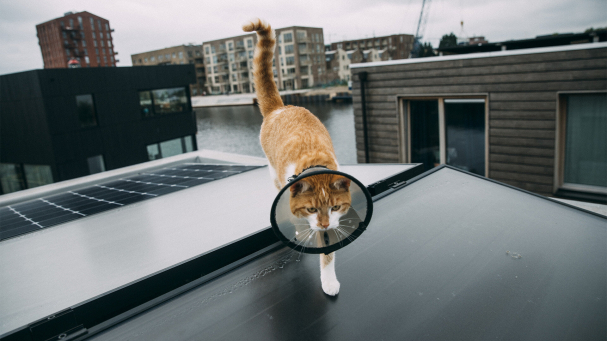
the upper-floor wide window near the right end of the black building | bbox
[139,88,188,117]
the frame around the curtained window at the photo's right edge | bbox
[552,90,607,195]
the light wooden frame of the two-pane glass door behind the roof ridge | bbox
[396,93,490,178]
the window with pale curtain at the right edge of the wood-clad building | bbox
[557,93,607,194]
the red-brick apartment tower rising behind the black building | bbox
[36,11,118,69]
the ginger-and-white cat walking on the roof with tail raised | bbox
[242,19,351,296]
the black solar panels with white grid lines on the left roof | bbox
[0,163,261,241]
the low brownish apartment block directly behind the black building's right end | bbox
[131,44,206,96]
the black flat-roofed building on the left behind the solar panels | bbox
[0,65,197,193]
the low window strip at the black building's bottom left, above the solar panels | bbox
[0,163,53,194]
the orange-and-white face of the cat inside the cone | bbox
[289,174,352,231]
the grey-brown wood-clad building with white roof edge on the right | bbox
[351,42,607,203]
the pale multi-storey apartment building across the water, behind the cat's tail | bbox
[202,26,327,94]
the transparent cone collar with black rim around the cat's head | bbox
[271,167,373,254]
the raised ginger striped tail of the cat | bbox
[242,19,284,117]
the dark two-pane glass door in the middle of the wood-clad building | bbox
[404,98,487,176]
